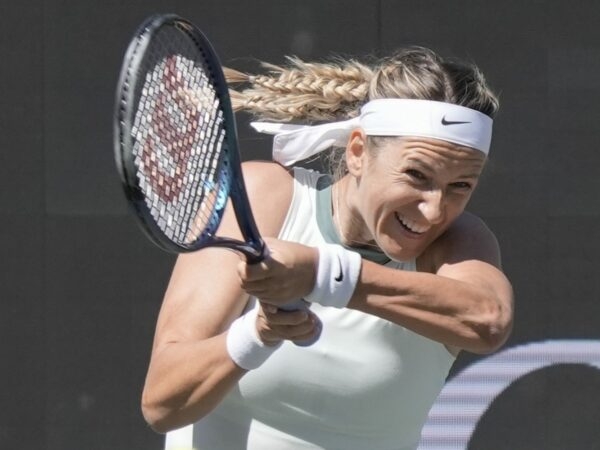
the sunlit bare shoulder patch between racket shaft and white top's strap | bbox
[242,161,294,236]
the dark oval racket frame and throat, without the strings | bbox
[113,14,268,264]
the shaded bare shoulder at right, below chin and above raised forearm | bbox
[418,212,501,272]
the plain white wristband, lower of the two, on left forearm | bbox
[227,308,283,370]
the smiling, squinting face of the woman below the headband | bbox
[349,134,485,260]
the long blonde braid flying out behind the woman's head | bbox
[225,57,373,122]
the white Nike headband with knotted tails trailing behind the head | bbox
[250,98,493,166]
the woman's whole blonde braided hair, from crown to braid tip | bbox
[225,47,499,174]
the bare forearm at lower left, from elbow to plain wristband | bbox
[142,333,246,433]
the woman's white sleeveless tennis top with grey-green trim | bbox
[166,168,454,450]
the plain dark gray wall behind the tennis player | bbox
[0,0,600,450]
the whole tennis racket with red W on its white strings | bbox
[114,14,320,345]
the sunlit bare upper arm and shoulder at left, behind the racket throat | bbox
[148,162,293,351]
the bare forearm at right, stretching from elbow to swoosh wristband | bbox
[348,261,512,353]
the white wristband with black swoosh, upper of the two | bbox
[304,244,362,308]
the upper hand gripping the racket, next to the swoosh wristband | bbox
[238,238,319,306]
